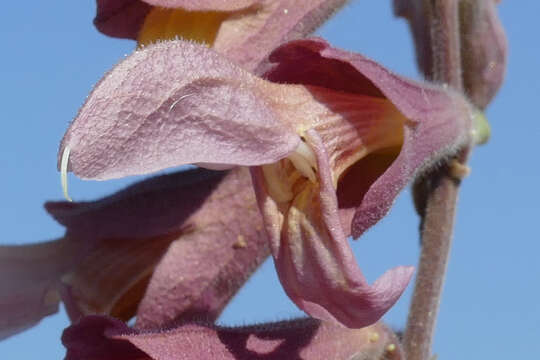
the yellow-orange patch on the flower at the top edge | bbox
[137,7,231,46]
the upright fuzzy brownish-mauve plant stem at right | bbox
[403,0,469,360]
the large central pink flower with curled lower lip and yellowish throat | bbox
[59,39,472,327]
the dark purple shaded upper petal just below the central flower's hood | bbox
[45,169,226,239]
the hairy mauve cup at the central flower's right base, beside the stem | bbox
[266,39,473,237]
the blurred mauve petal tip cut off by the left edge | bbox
[0,238,84,339]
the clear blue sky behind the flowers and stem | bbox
[0,0,540,360]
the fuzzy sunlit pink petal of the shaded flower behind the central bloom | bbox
[137,168,270,328]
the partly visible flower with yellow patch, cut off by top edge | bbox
[94,0,346,70]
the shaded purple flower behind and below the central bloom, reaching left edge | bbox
[0,168,270,338]
